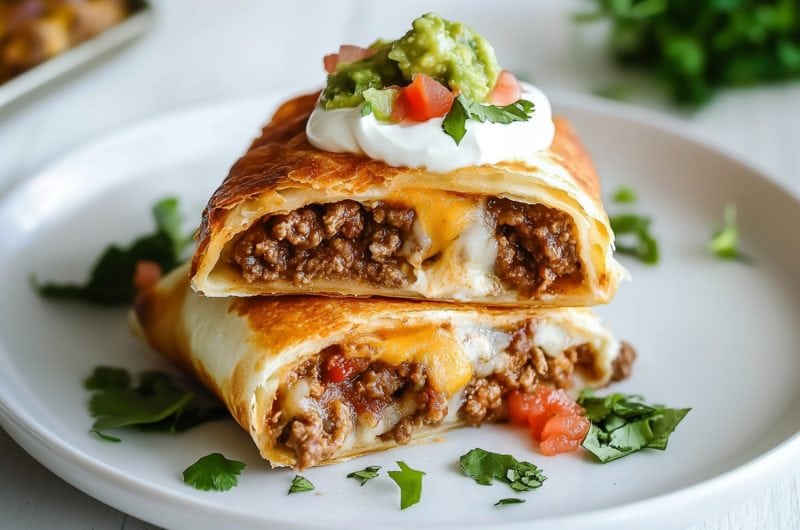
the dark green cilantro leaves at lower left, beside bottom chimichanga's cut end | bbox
[84,366,227,442]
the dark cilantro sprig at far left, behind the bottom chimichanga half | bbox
[31,198,191,305]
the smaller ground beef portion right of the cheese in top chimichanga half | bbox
[487,198,582,297]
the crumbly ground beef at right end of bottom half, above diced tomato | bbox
[458,322,636,425]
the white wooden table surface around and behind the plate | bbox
[0,0,800,530]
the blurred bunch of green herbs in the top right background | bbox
[576,0,800,106]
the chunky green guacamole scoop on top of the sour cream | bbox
[322,13,500,109]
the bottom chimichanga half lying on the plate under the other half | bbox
[134,268,633,468]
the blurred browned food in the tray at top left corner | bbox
[0,0,131,83]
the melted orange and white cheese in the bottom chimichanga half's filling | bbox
[279,311,619,458]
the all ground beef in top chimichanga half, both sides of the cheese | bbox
[230,194,582,292]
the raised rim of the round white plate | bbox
[0,87,800,528]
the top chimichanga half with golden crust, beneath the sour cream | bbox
[192,94,626,306]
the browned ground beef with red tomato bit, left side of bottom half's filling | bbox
[268,346,447,469]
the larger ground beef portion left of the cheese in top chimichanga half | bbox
[231,200,416,288]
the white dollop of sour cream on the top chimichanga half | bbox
[306,83,555,173]
